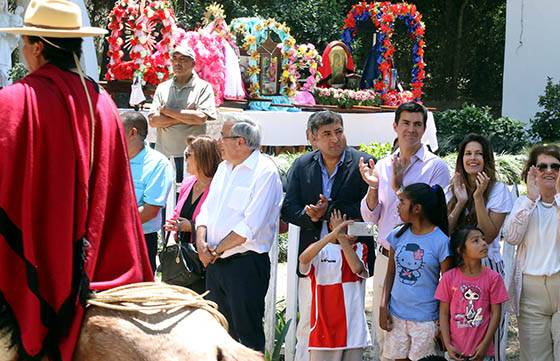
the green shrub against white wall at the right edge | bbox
[531,78,560,143]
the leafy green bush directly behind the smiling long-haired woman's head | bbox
[434,104,527,155]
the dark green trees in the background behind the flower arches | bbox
[87,0,506,112]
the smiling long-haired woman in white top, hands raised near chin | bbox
[445,134,513,361]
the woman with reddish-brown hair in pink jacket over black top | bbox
[164,136,222,293]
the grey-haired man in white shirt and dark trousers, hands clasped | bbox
[196,116,282,351]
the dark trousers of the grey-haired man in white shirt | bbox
[206,252,270,352]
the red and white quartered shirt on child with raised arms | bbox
[300,243,371,350]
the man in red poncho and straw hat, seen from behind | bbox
[0,0,153,360]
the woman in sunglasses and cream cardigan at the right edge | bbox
[503,145,560,361]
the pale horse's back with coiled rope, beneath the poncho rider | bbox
[0,283,264,361]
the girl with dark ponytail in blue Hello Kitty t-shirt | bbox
[379,183,451,361]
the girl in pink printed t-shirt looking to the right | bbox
[435,226,508,360]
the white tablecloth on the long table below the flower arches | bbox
[144,111,438,151]
